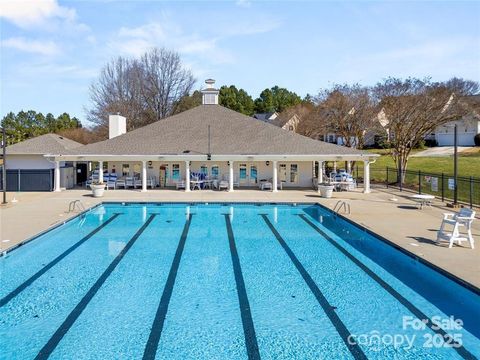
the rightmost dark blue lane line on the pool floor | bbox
[299,214,477,360]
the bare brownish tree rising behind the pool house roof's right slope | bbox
[299,84,378,149]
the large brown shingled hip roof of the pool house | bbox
[63,105,364,155]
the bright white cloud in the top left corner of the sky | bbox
[0,0,76,29]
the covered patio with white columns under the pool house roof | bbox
[47,155,375,193]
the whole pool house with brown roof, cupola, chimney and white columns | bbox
[45,81,376,193]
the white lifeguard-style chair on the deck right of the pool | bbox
[437,208,475,249]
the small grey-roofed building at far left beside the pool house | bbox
[5,134,83,191]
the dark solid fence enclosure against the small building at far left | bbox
[0,169,54,191]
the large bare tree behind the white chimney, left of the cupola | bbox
[87,48,195,131]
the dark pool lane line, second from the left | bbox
[35,214,158,360]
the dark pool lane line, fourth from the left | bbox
[223,214,260,360]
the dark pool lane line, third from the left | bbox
[143,214,192,359]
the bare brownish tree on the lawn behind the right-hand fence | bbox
[375,78,465,182]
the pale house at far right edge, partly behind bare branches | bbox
[434,95,480,146]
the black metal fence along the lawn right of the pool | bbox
[359,167,480,207]
